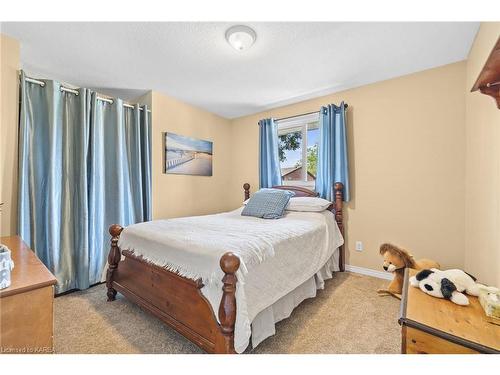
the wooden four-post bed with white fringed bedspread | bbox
[106,183,345,354]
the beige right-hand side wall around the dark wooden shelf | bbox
[465,22,500,286]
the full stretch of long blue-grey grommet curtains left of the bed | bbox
[18,72,151,293]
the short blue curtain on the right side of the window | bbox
[316,102,350,202]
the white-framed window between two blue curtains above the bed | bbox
[277,113,319,190]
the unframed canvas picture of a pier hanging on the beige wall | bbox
[163,132,213,176]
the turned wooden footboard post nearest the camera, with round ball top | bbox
[216,252,240,353]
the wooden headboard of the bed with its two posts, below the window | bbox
[243,182,345,272]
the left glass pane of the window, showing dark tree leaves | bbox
[278,127,303,185]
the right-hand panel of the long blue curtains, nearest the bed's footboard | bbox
[88,93,151,284]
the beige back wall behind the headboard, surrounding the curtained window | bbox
[229,62,465,270]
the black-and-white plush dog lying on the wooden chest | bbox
[410,268,498,306]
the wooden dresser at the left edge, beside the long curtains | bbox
[0,236,56,354]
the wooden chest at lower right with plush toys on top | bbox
[399,268,500,354]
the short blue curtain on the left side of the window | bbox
[259,119,281,188]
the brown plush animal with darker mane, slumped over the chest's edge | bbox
[377,243,439,299]
